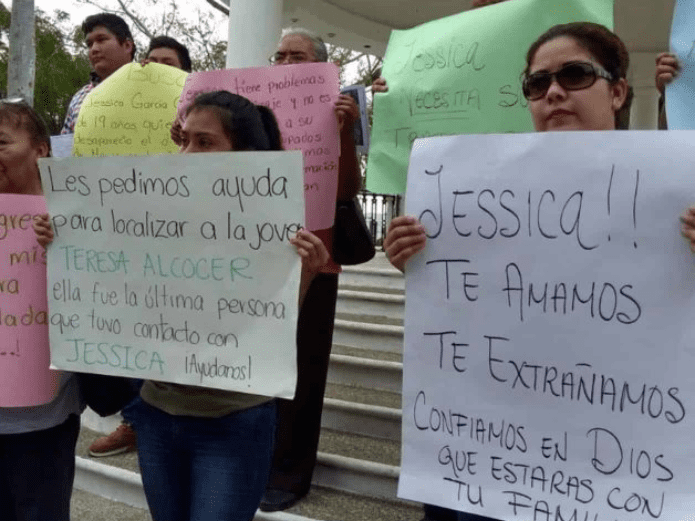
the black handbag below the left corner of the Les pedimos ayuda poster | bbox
[76,373,142,417]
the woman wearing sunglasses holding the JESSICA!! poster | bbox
[384,22,632,271]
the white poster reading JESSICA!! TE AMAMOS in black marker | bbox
[399,132,695,521]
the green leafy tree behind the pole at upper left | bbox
[0,3,90,134]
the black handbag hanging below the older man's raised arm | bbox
[333,199,376,265]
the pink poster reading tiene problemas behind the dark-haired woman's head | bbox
[178,63,340,230]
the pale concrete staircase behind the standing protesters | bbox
[75,253,422,521]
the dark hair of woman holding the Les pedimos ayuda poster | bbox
[186,90,282,150]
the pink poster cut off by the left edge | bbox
[0,194,59,407]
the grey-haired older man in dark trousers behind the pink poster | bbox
[261,28,361,512]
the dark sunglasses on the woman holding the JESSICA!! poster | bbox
[522,62,613,101]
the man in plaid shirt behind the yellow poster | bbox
[60,13,135,134]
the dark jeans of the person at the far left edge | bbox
[0,414,80,521]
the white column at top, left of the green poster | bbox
[227,0,284,69]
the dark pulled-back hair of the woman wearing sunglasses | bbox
[524,22,632,128]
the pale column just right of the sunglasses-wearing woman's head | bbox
[629,52,659,130]
